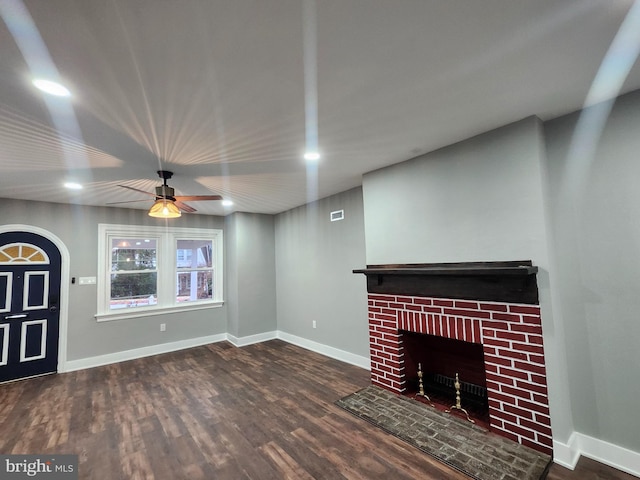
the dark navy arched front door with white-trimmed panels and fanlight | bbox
[0,232,61,382]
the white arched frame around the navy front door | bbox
[0,224,71,373]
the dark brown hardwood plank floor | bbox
[0,340,634,480]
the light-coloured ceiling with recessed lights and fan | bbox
[0,0,640,215]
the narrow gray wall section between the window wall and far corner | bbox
[225,213,277,338]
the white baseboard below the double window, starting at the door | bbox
[61,333,227,373]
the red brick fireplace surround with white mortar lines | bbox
[369,294,552,454]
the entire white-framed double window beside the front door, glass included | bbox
[96,224,223,321]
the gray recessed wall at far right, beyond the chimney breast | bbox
[545,92,640,452]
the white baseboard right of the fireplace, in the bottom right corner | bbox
[553,432,640,477]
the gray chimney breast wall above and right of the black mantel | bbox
[363,117,573,442]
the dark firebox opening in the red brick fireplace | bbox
[399,330,490,428]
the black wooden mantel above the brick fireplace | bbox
[353,260,538,304]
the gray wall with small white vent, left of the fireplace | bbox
[275,188,369,358]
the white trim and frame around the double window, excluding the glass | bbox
[95,223,224,322]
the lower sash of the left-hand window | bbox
[109,272,158,310]
